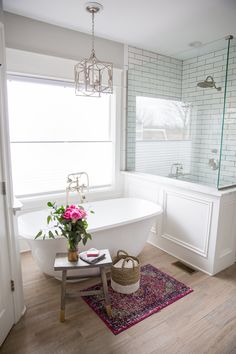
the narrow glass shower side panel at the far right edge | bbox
[217,38,236,189]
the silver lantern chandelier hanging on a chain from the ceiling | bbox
[75,2,113,97]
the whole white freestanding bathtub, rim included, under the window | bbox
[18,198,162,277]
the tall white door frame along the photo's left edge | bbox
[0,22,26,323]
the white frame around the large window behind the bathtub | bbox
[7,49,123,207]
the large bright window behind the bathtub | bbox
[8,76,114,196]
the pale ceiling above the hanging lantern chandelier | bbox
[3,0,236,56]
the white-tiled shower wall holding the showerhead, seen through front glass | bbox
[182,39,227,187]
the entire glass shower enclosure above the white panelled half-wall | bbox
[127,36,236,189]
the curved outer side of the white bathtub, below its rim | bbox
[27,217,155,280]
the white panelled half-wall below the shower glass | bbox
[124,173,236,275]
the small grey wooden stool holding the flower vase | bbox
[54,249,112,322]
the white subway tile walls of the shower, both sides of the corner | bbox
[126,43,236,186]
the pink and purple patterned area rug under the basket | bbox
[83,264,193,334]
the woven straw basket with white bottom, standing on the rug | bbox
[111,250,140,294]
